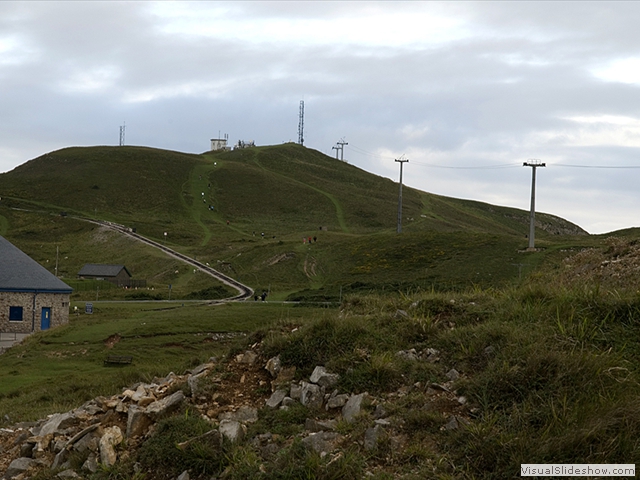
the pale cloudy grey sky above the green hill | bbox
[0,0,640,233]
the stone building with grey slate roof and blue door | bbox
[0,236,73,333]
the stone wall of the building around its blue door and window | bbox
[0,292,69,333]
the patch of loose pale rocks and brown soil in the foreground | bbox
[0,346,472,480]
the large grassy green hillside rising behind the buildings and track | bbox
[0,144,589,299]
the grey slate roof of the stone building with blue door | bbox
[0,236,73,293]
